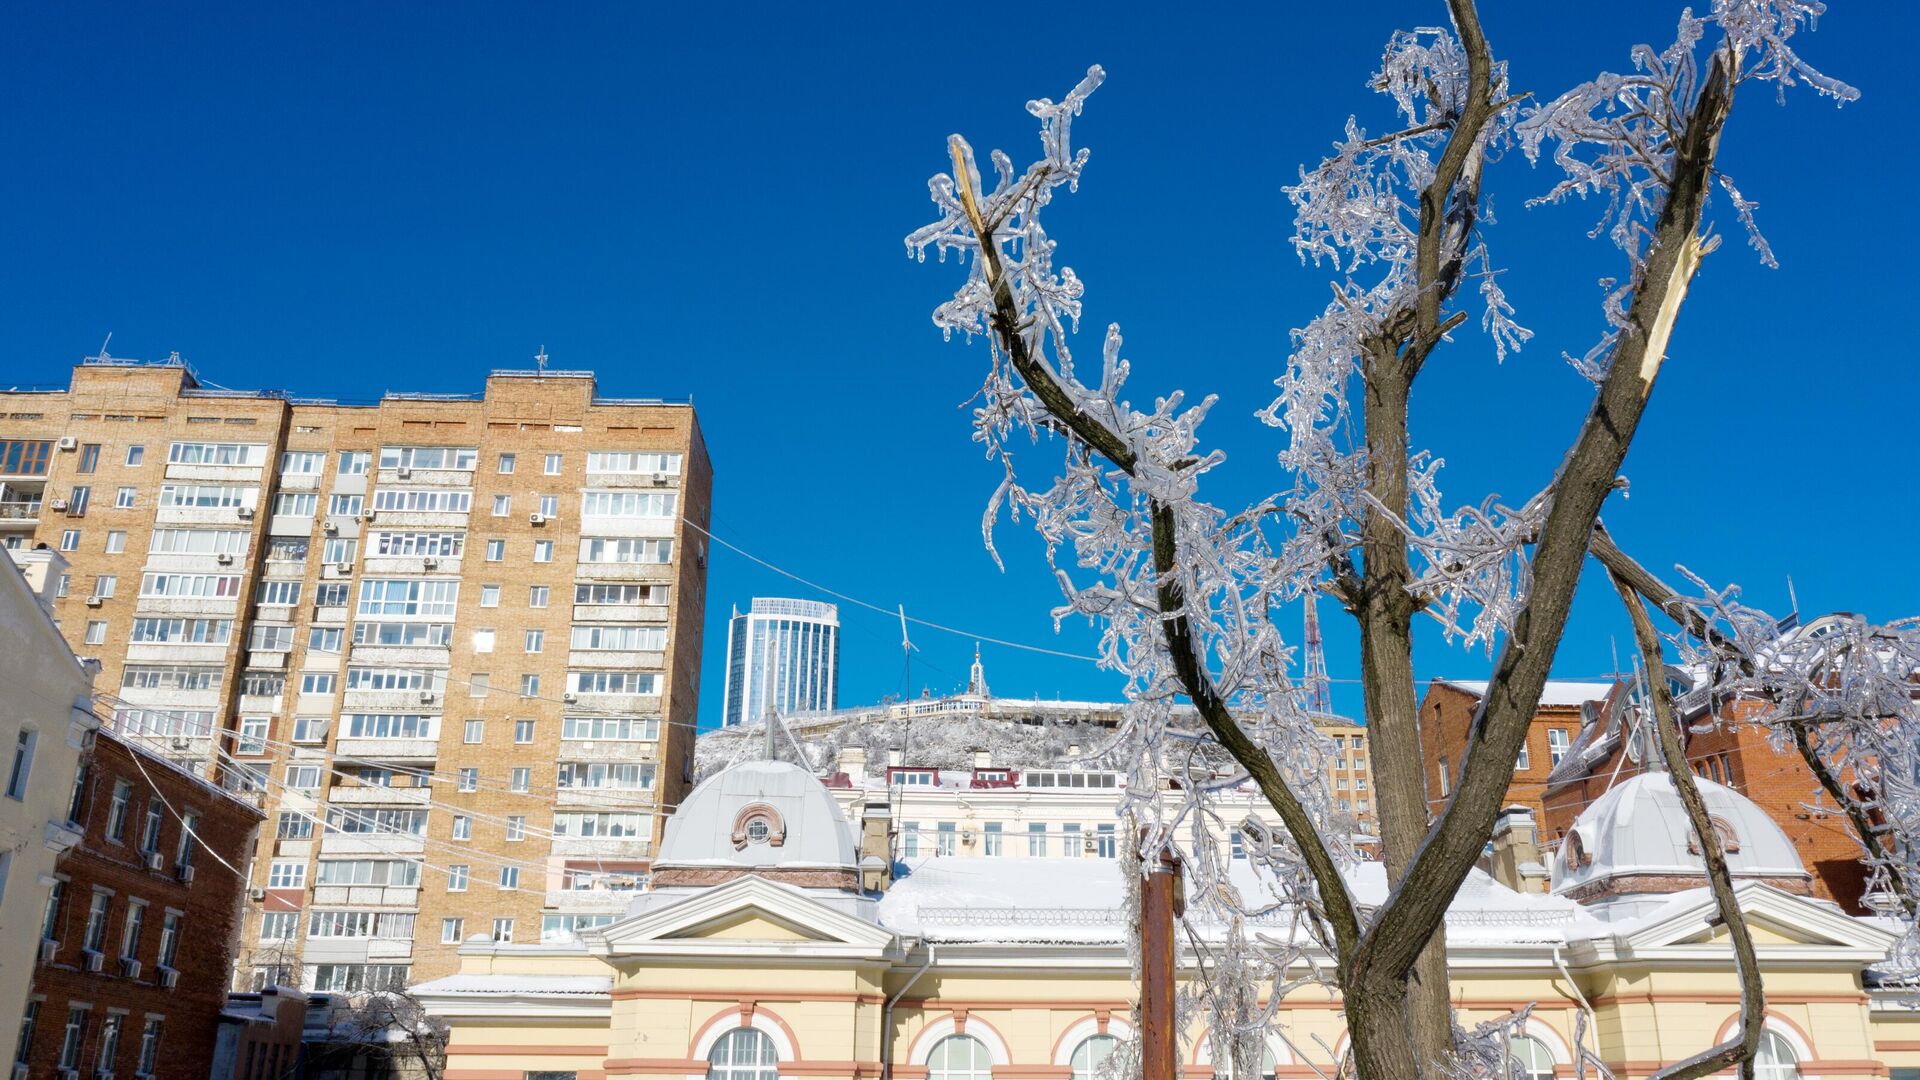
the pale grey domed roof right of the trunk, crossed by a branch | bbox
[1553,773,1809,899]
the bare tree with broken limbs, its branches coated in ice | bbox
[906,0,1881,1080]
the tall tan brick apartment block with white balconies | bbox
[0,357,712,990]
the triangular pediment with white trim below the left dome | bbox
[582,878,895,955]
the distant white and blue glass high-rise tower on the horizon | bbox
[720,596,839,726]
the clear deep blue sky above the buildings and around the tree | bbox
[0,0,1920,723]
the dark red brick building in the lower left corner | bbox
[10,730,265,1080]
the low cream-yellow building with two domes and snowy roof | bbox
[415,761,1920,1080]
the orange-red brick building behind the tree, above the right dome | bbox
[1421,671,1866,915]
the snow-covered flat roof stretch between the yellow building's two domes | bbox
[879,857,1607,944]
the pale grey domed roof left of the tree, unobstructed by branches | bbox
[653,761,860,884]
